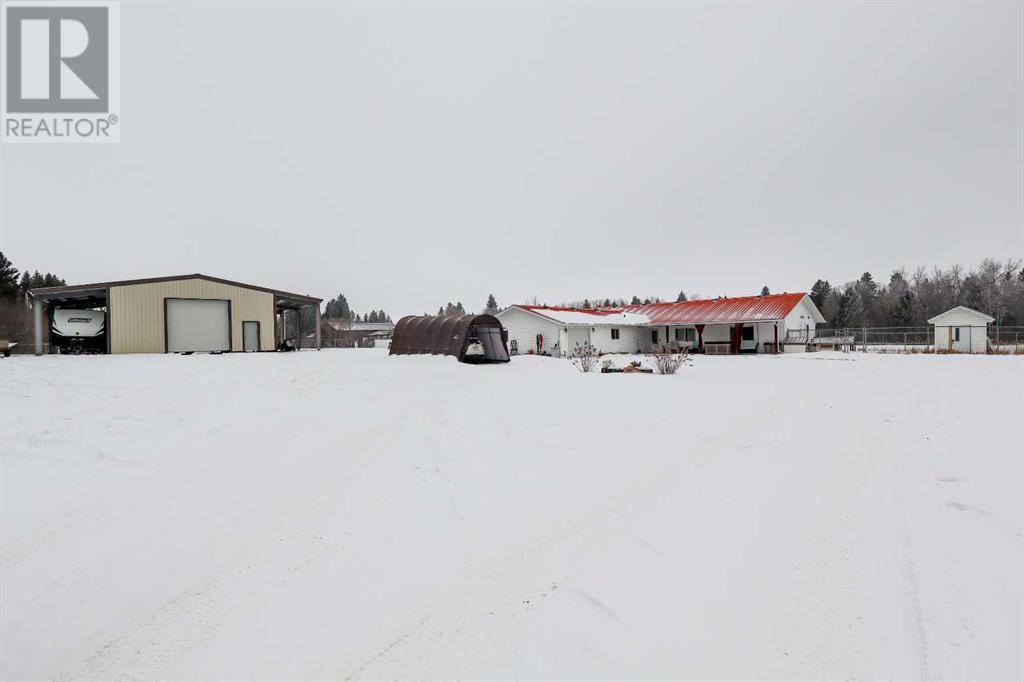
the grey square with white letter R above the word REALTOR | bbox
[4,6,110,114]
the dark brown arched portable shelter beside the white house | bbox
[390,314,509,363]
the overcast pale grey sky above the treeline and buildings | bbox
[0,2,1024,318]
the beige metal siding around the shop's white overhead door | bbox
[109,280,273,353]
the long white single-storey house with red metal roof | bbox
[498,293,824,357]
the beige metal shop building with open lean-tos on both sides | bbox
[30,273,322,355]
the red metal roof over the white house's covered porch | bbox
[625,293,807,325]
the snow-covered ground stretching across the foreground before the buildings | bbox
[0,350,1024,680]
